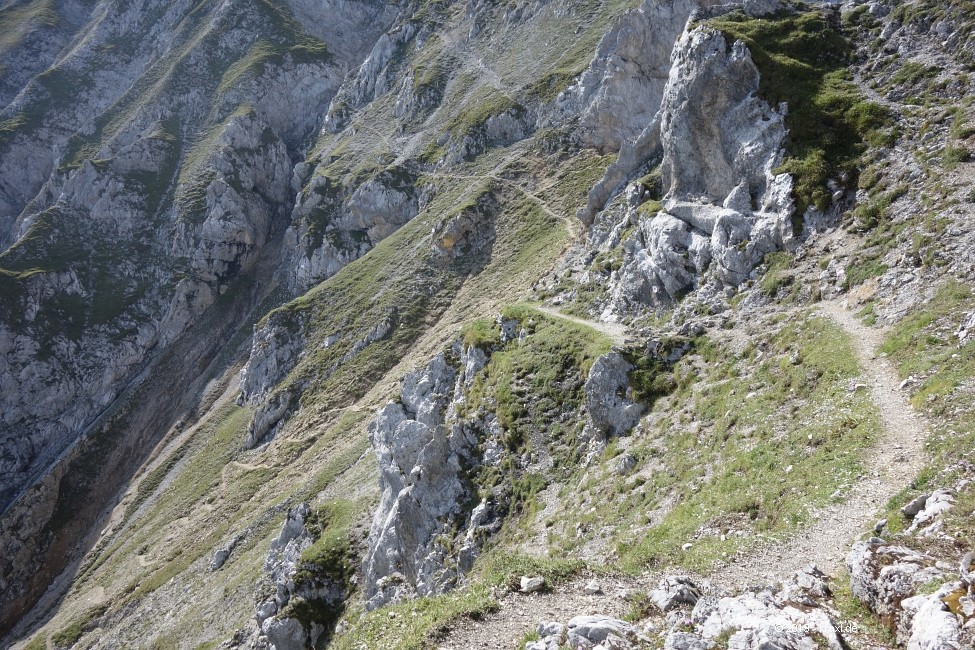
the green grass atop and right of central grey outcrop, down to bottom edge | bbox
[335,305,610,649]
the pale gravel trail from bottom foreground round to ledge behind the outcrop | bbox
[437,300,928,650]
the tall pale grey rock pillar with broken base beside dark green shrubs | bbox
[604,27,794,317]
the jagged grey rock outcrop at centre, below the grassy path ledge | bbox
[362,336,520,609]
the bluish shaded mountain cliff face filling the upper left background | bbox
[0,3,402,503]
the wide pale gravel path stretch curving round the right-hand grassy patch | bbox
[712,301,928,586]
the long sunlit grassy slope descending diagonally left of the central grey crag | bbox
[30,151,588,638]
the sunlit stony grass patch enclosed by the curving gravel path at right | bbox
[616,316,880,572]
